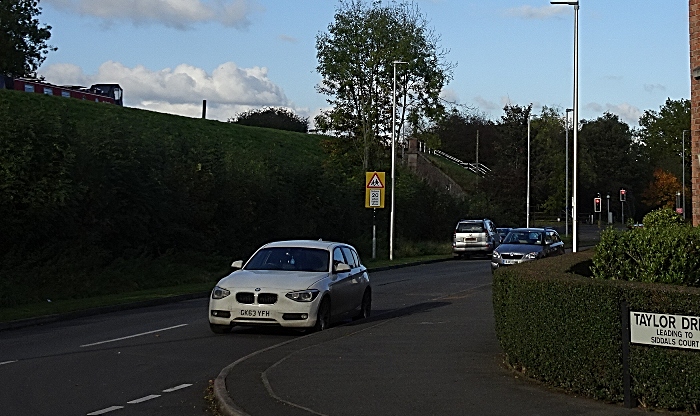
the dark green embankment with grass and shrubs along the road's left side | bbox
[0,90,470,307]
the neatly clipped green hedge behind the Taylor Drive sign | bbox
[493,251,700,412]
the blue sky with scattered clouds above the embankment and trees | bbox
[38,0,691,127]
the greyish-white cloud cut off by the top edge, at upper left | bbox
[44,0,256,29]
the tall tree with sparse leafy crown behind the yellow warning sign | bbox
[315,0,452,169]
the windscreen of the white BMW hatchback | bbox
[245,247,330,272]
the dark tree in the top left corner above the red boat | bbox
[0,0,57,77]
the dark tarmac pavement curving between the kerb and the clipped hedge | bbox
[214,276,647,416]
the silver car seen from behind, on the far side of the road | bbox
[452,219,501,257]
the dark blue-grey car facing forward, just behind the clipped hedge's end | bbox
[491,228,564,271]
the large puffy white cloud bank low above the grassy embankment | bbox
[40,61,293,121]
